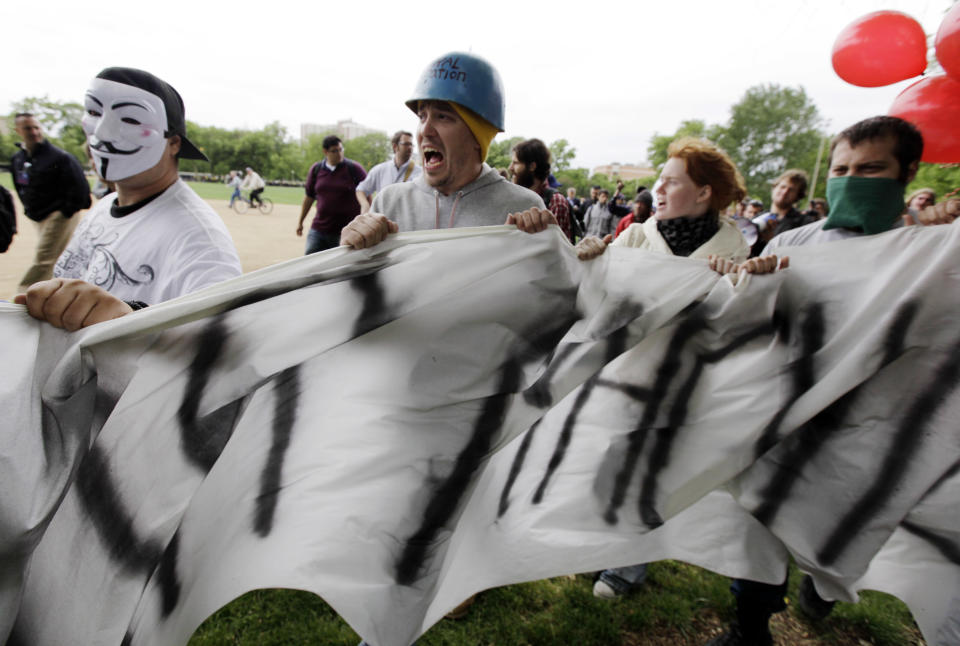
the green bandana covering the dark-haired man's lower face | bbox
[823,176,907,235]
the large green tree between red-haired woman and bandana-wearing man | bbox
[714,84,822,201]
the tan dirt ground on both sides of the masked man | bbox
[0,196,309,300]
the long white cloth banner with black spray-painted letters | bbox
[0,226,960,646]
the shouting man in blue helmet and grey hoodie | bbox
[340,52,557,249]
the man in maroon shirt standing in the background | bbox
[297,135,367,255]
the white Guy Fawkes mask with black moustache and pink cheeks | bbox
[82,78,167,182]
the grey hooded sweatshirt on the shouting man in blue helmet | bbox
[370,164,544,231]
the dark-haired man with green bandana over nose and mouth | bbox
[707,116,960,646]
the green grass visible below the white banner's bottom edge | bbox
[190,561,923,646]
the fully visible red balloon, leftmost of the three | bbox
[833,11,927,87]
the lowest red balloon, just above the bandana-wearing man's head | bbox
[890,75,960,164]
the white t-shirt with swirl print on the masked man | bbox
[53,180,242,305]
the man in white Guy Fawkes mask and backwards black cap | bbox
[15,67,241,329]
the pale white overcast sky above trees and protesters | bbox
[0,0,952,168]
